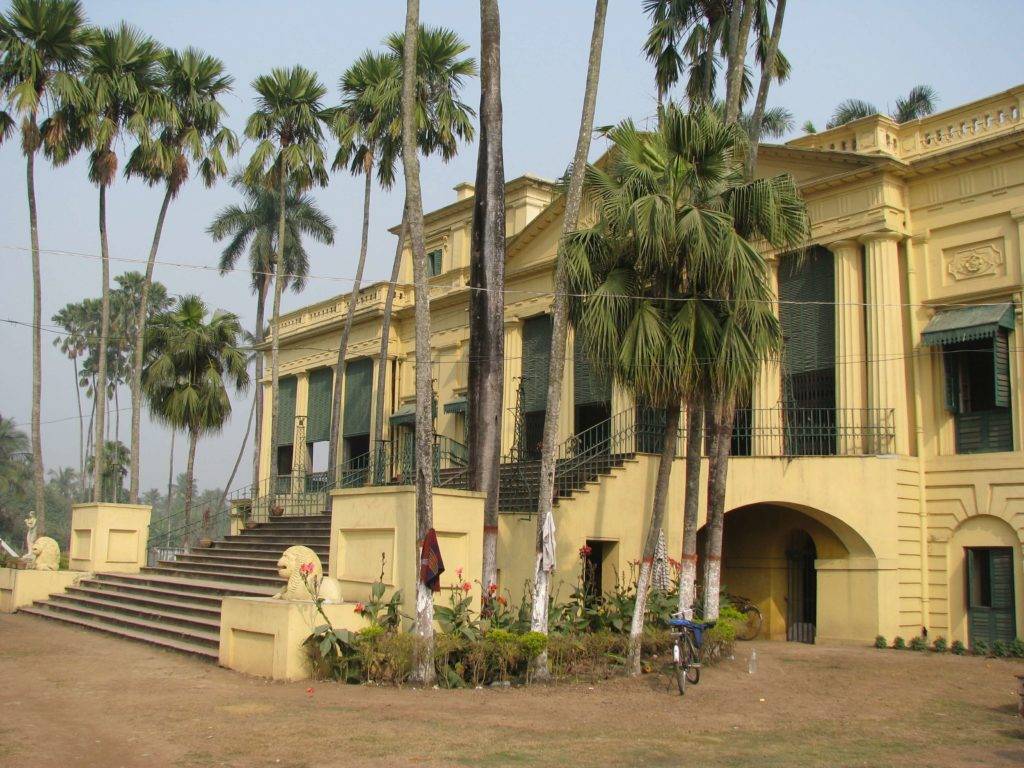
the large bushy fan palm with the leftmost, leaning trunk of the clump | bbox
[565,104,806,672]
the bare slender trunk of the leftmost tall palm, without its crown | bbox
[25,145,46,536]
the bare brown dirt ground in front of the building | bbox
[0,614,1024,768]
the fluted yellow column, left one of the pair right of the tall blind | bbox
[827,240,867,456]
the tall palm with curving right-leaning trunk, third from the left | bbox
[125,48,238,504]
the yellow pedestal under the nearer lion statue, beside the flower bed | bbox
[220,597,367,680]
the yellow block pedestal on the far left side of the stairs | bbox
[68,503,152,573]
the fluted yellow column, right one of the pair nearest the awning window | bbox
[860,230,907,454]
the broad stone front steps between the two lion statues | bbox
[20,515,331,660]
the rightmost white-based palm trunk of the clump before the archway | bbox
[703,395,736,622]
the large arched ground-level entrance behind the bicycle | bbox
[698,503,888,642]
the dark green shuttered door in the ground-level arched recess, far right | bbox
[965,547,1017,647]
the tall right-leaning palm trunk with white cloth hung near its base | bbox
[530,0,608,680]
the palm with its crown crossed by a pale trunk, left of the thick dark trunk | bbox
[362,26,477,444]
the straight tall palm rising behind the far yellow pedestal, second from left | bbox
[56,23,170,502]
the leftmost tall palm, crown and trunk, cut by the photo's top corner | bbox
[0,0,91,535]
